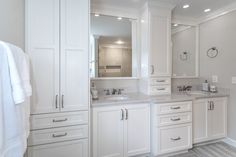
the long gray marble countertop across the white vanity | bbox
[91,91,229,107]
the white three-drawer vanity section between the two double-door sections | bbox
[151,101,192,156]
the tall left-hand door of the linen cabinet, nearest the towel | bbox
[26,0,59,114]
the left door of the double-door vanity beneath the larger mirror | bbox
[92,106,124,157]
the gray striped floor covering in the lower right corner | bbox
[171,142,236,157]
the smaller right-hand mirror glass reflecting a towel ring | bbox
[171,23,199,78]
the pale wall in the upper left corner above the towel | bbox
[0,0,24,49]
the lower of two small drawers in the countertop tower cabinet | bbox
[150,85,171,95]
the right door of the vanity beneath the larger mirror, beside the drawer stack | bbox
[124,104,150,156]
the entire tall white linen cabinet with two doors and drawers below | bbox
[25,0,89,157]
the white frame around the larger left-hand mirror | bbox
[89,8,141,80]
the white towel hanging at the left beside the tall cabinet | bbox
[0,41,32,157]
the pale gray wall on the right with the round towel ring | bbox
[200,11,236,140]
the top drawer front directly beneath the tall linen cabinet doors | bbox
[31,111,88,130]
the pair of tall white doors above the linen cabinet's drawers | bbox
[26,0,89,114]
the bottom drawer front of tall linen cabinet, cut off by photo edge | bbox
[28,139,88,157]
